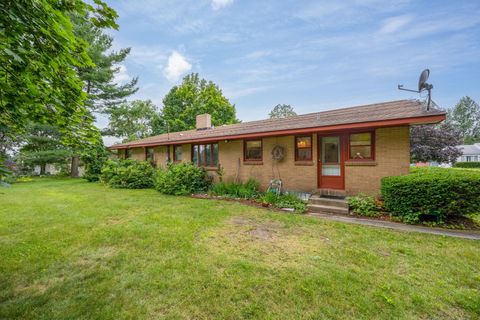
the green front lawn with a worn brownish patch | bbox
[0,179,480,319]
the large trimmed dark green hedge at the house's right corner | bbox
[381,168,480,223]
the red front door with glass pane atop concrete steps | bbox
[318,134,345,190]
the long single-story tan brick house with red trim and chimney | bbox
[110,100,445,195]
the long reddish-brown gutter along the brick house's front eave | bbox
[109,114,446,150]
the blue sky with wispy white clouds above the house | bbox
[98,0,480,138]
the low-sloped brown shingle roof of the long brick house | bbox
[111,100,445,149]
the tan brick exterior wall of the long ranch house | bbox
[117,126,410,194]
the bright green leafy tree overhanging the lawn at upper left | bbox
[0,0,117,176]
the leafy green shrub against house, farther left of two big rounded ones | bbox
[100,159,155,189]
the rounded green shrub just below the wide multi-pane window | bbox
[155,163,211,195]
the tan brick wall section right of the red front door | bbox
[345,127,410,194]
